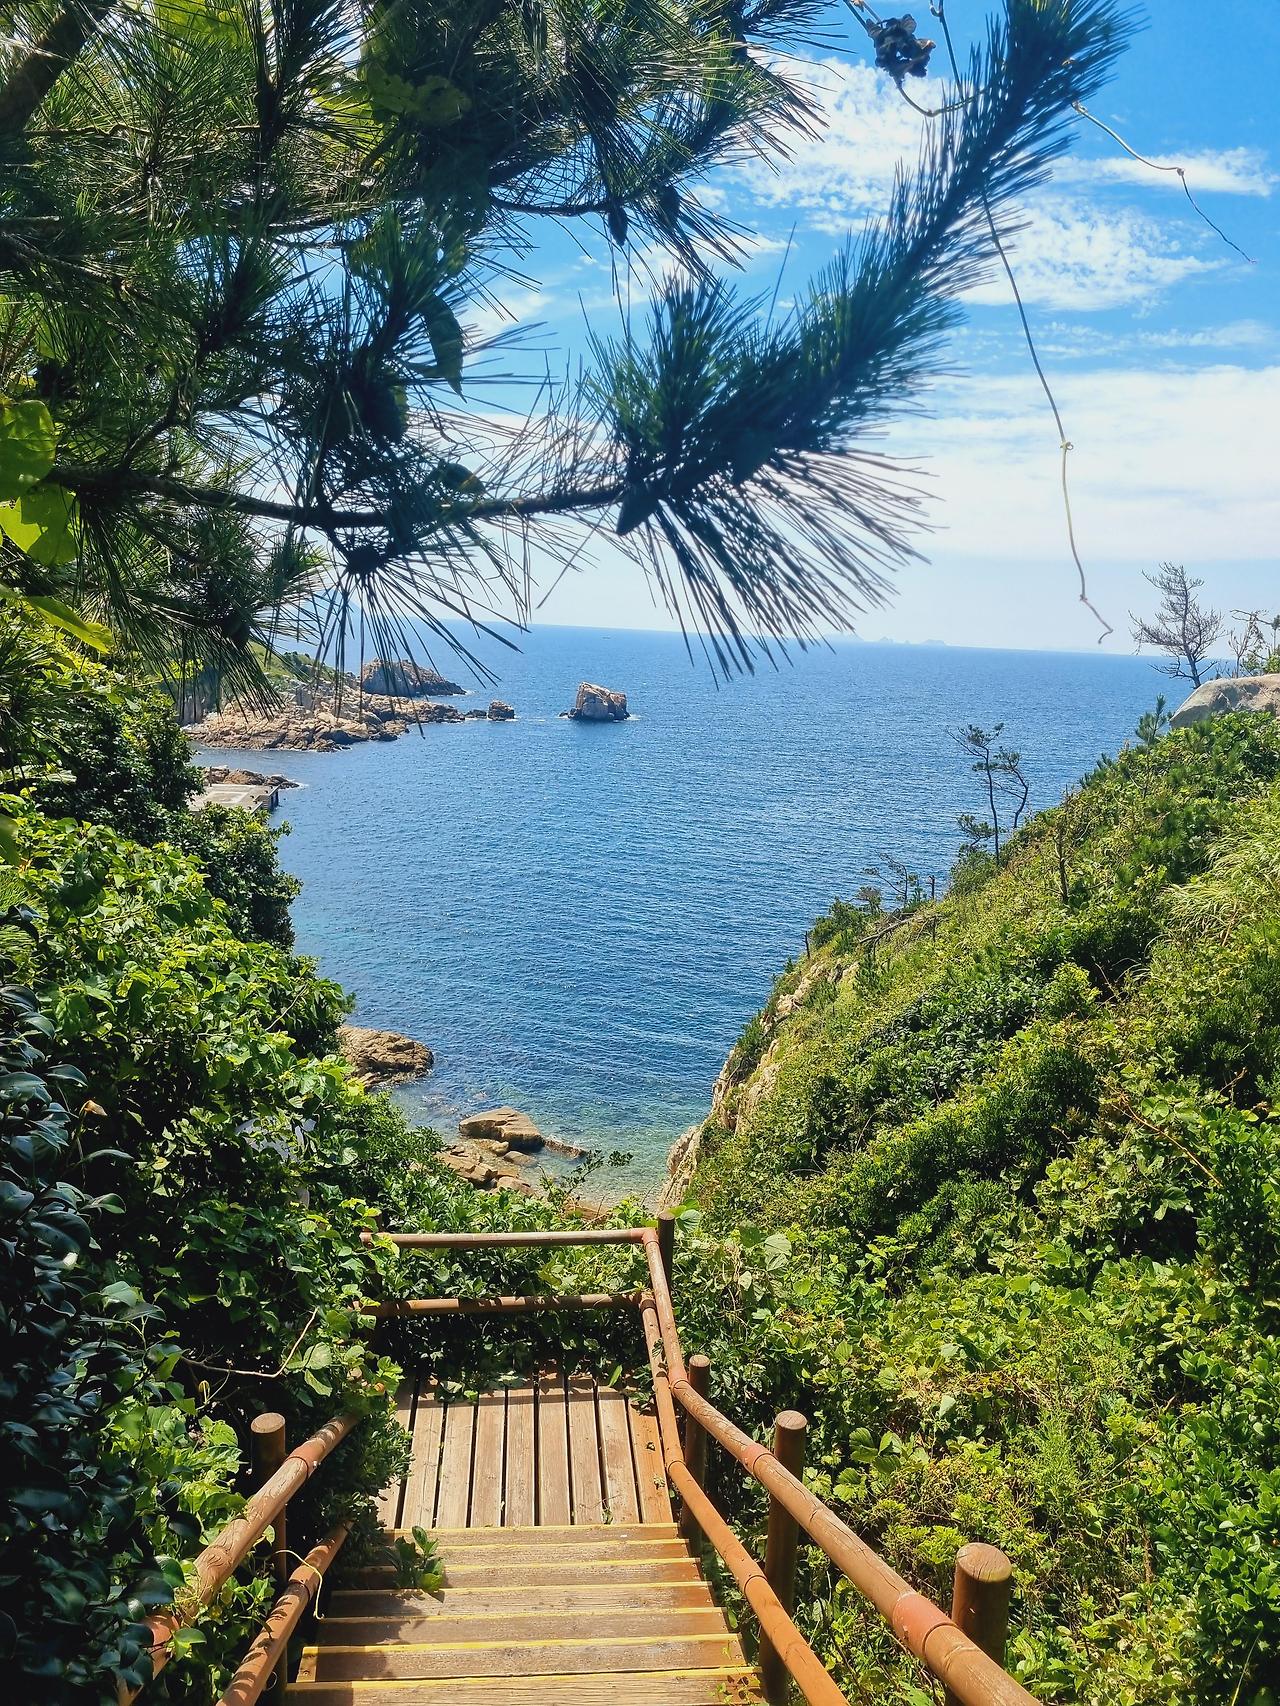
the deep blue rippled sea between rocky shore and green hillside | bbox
[200,628,1161,1184]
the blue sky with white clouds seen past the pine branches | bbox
[476,0,1280,650]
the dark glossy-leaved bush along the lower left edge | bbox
[0,986,168,1703]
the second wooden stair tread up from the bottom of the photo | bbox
[299,1631,744,1697]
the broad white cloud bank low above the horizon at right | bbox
[891,365,1280,563]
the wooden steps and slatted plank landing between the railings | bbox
[288,1372,761,1706]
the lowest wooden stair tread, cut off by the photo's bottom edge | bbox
[288,1667,763,1706]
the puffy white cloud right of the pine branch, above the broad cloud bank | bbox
[968,194,1222,312]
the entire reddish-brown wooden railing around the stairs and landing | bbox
[130,1215,1038,1706]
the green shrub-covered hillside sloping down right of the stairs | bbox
[672,717,1280,1706]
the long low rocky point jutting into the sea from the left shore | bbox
[191,684,481,752]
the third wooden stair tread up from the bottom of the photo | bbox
[314,1605,727,1646]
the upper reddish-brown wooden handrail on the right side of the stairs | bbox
[642,1228,1039,1706]
